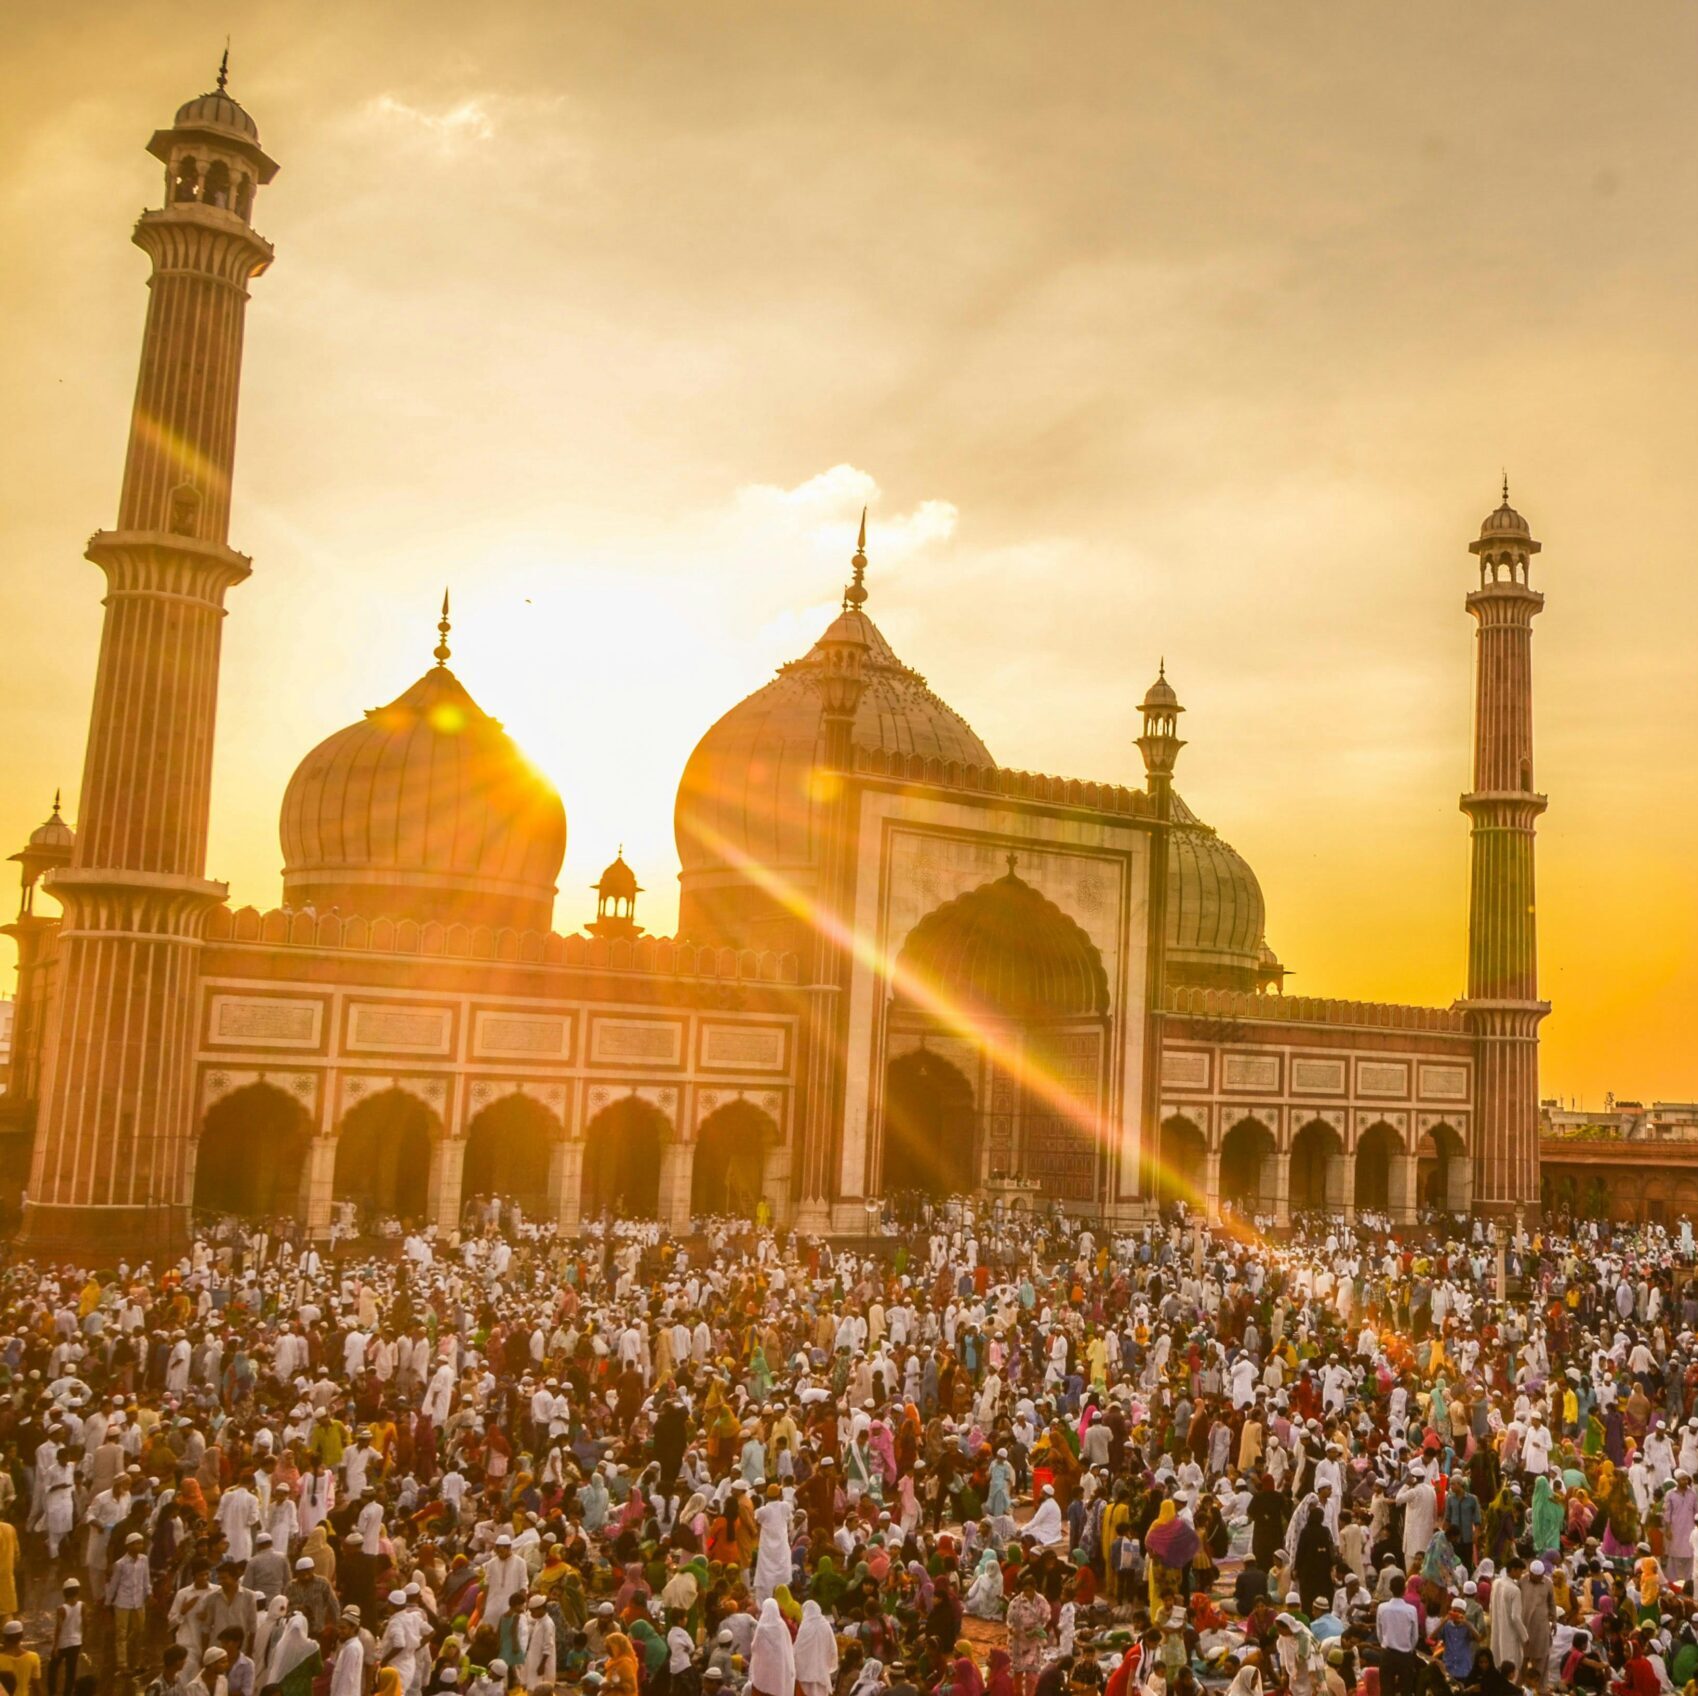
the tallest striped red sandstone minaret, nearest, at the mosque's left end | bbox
[24,54,277,1261]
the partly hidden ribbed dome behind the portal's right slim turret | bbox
[1167,795,1267,990]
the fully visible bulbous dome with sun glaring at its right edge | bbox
[280,665,565,930]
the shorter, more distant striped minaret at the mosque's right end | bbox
[1462,477,1550,1216]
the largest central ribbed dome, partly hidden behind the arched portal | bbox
[672,613,995,947]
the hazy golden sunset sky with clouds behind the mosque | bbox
[0,0,1698,1102]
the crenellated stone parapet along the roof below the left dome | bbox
[205,907,800,983]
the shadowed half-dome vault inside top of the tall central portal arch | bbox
[897,868,1109,1020]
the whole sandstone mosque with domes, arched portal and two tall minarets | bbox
[0,71,1549,1258]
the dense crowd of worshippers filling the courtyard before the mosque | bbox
[0,1200,1698,1696]
